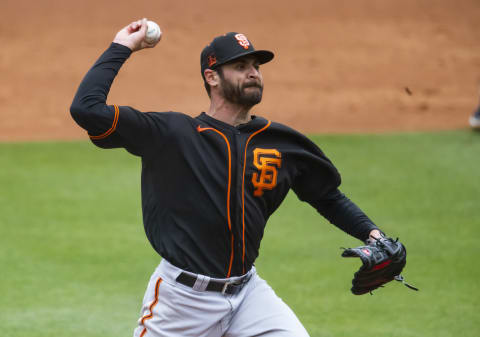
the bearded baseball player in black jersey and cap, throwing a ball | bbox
[70,19,382,337]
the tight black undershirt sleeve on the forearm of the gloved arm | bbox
[310,189,378,241]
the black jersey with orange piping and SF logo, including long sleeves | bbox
[71,43,376,278]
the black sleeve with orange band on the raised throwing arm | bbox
[70,43,169,156]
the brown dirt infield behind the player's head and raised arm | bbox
[0,0,480,141]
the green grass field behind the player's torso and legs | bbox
[0,130,480,337]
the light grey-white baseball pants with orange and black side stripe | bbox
[134,259,308,337]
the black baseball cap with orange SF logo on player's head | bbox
[200,32,274,77]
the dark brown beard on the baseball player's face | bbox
[221,76,263,108]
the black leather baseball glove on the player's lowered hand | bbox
[342,237,418,295]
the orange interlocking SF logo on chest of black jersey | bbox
[252,148,282,197]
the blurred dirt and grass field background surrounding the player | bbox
[0,0,480,337]
